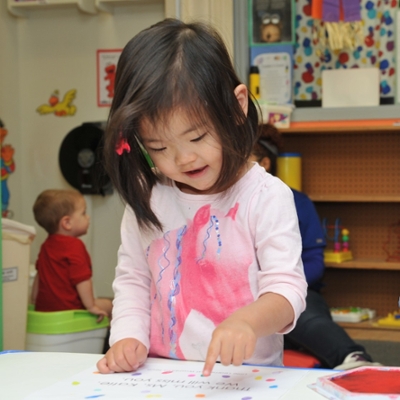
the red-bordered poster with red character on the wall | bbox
[97,49,122,107]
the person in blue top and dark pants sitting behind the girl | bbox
[250,124,380,370]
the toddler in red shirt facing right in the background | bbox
[32,190,112,322]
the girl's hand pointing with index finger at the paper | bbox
[203,316,257,376]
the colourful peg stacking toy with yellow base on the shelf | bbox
[322,218,353,263]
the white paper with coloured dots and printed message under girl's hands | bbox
[26,358,308,400]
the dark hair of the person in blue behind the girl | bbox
[252,123,283,175]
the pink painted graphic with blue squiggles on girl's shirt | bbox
[148,203,254,359]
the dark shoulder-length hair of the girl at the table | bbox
[104,19,258,229]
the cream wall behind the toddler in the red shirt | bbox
[0,1,164,296]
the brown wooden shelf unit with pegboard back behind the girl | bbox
[282,122,400,341]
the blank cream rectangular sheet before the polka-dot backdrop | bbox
[322,68,380,108]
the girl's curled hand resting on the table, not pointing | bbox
[97,339,147,374]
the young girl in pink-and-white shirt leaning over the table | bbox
[97,19,306,376]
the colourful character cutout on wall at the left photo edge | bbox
[0,119,15,218]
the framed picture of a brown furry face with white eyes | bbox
[248,0,296,46]
